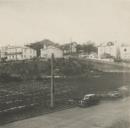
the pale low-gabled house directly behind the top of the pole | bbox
[41,46,63,59]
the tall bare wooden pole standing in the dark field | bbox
[50,53,54,108]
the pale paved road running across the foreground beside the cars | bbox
[0,98,130,128]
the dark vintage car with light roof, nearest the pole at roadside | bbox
[79,94,100,107]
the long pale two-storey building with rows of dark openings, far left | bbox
[1,45,36,61]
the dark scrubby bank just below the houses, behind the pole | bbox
[0,58,92,81]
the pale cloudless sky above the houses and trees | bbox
[0,0,130,46]
